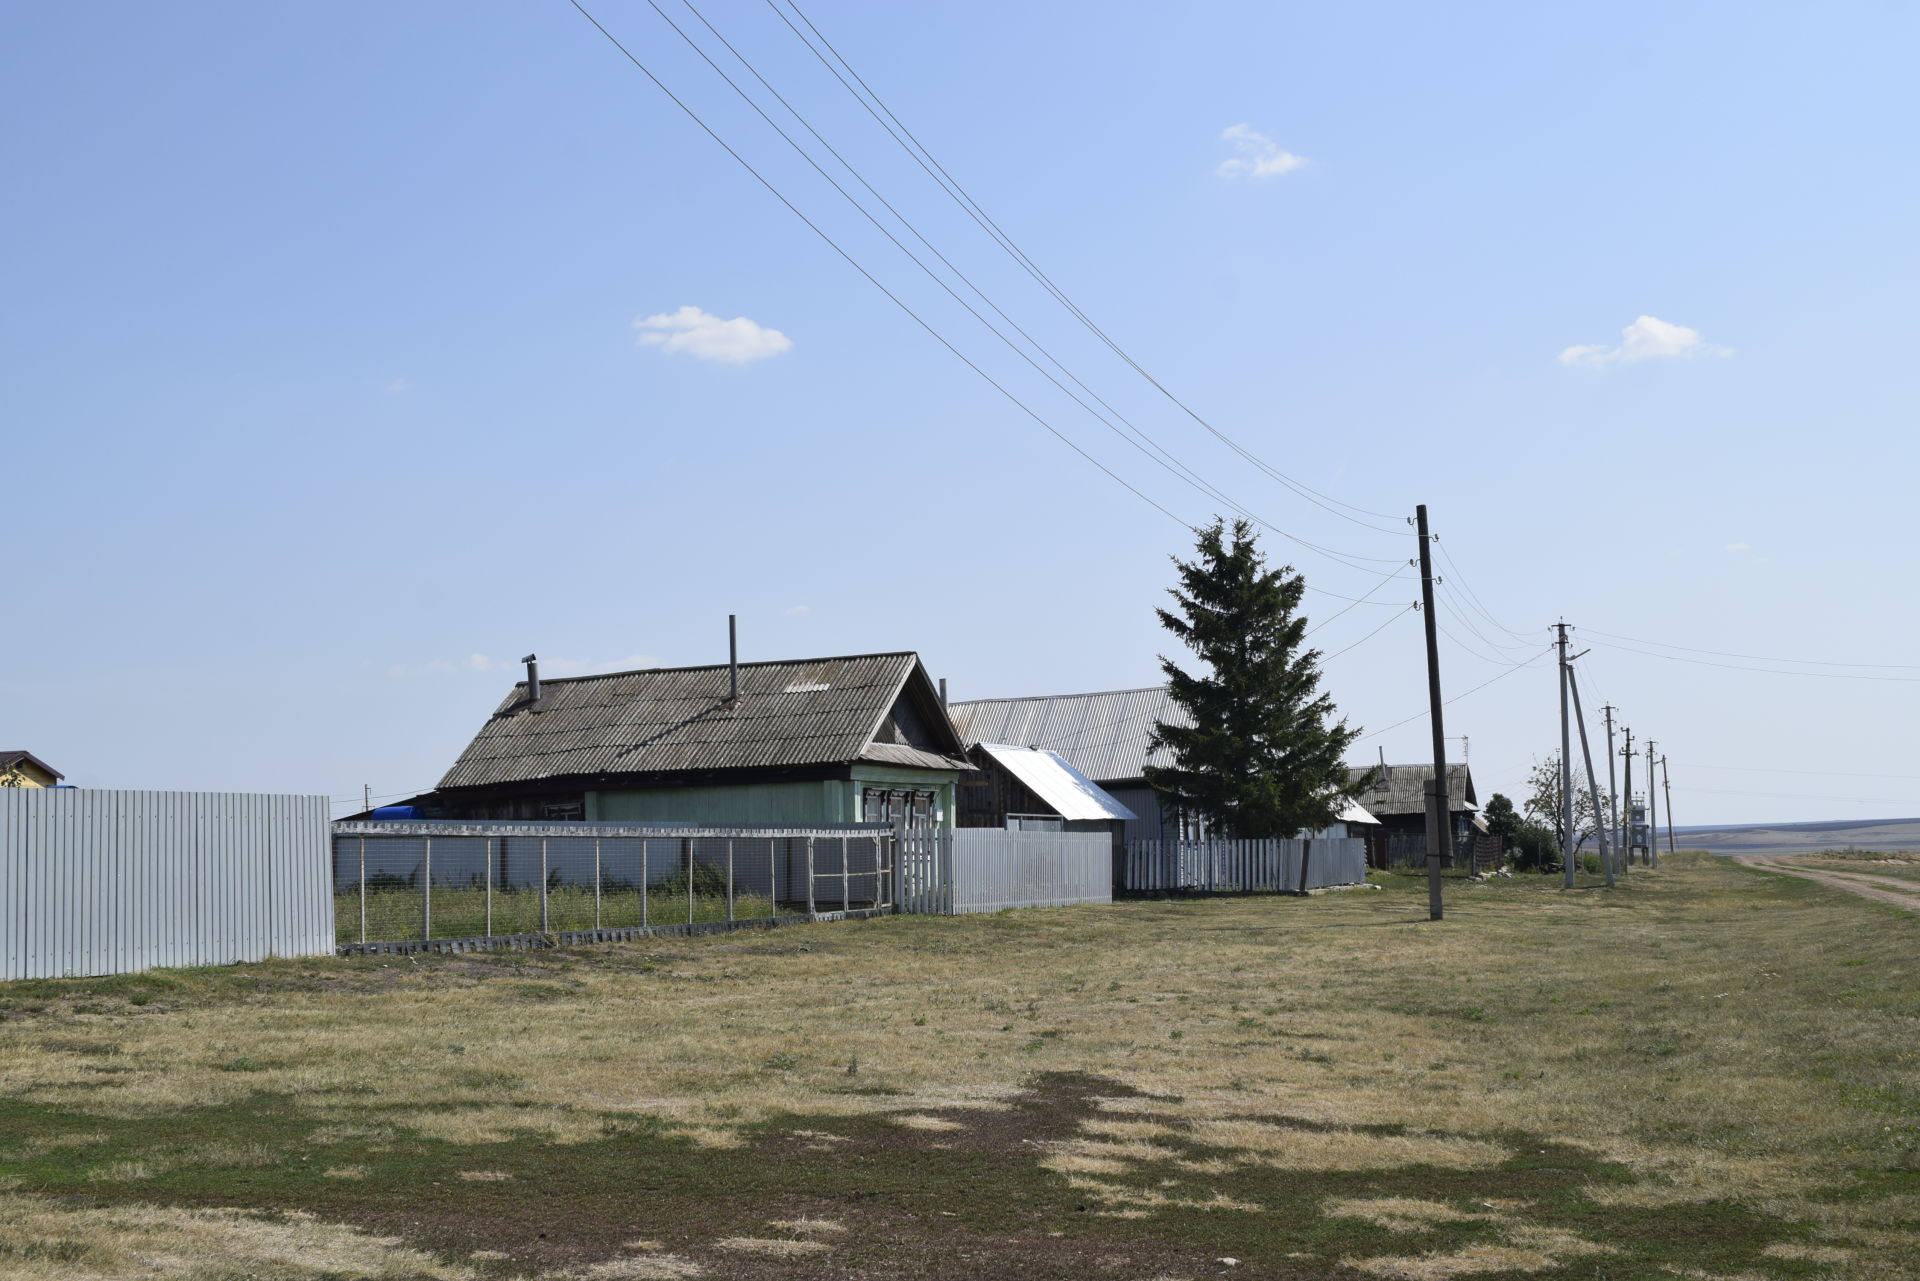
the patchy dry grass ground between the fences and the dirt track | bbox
[0,857,1920,1281]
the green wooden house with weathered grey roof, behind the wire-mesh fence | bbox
[415,653,973,828]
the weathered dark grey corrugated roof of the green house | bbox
[440,653,970,787]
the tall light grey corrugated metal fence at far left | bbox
[0,787,334,979]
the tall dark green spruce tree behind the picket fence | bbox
[1146,520,1365,837]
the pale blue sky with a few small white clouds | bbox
[0,0,1920,822]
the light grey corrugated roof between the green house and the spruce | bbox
[947,686,1188,782]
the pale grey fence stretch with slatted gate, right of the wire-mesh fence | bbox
[899,828,1114,916]
